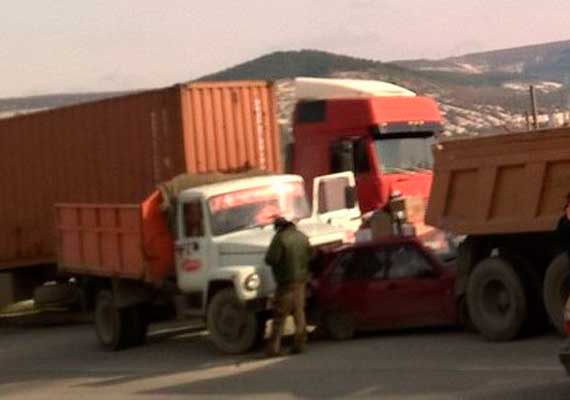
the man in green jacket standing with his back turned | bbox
[265,217,312,356]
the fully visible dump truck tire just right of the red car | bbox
[467,257,527,341]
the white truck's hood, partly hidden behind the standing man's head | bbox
[216,220,346,255]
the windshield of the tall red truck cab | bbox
[375,136,435,173]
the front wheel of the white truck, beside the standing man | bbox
[207,288,263,354]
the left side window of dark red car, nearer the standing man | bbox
[333,249,388,281]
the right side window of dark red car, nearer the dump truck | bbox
[388,245,434,279]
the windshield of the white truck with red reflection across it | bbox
[208,182,310,235]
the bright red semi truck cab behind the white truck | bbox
[292,80,442,213]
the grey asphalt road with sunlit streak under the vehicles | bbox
[0,318,570,400]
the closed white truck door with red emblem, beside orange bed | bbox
[175,199,209,292]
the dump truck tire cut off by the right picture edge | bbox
[542,253,570,335]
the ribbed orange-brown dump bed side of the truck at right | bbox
[426,128,570,235]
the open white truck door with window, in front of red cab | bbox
[313,172,362,231]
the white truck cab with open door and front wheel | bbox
[170,174,360,353]
